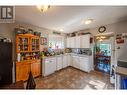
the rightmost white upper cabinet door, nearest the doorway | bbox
[80,34,90,48]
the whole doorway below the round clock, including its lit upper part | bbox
[94,34,114,74]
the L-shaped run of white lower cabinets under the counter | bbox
[42,54,93,76]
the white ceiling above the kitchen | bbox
[16,6,127,33]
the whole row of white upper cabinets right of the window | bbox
[67,34,90,48]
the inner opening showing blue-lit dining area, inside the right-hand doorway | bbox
[94,42,111,74]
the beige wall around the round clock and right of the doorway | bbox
[73,21,127,68]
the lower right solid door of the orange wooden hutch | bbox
[31,61,41,77]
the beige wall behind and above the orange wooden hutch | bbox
[0,22,65,82]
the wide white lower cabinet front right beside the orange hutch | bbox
[43,57,56,76]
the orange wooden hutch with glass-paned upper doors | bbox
[16,34,41,81]
